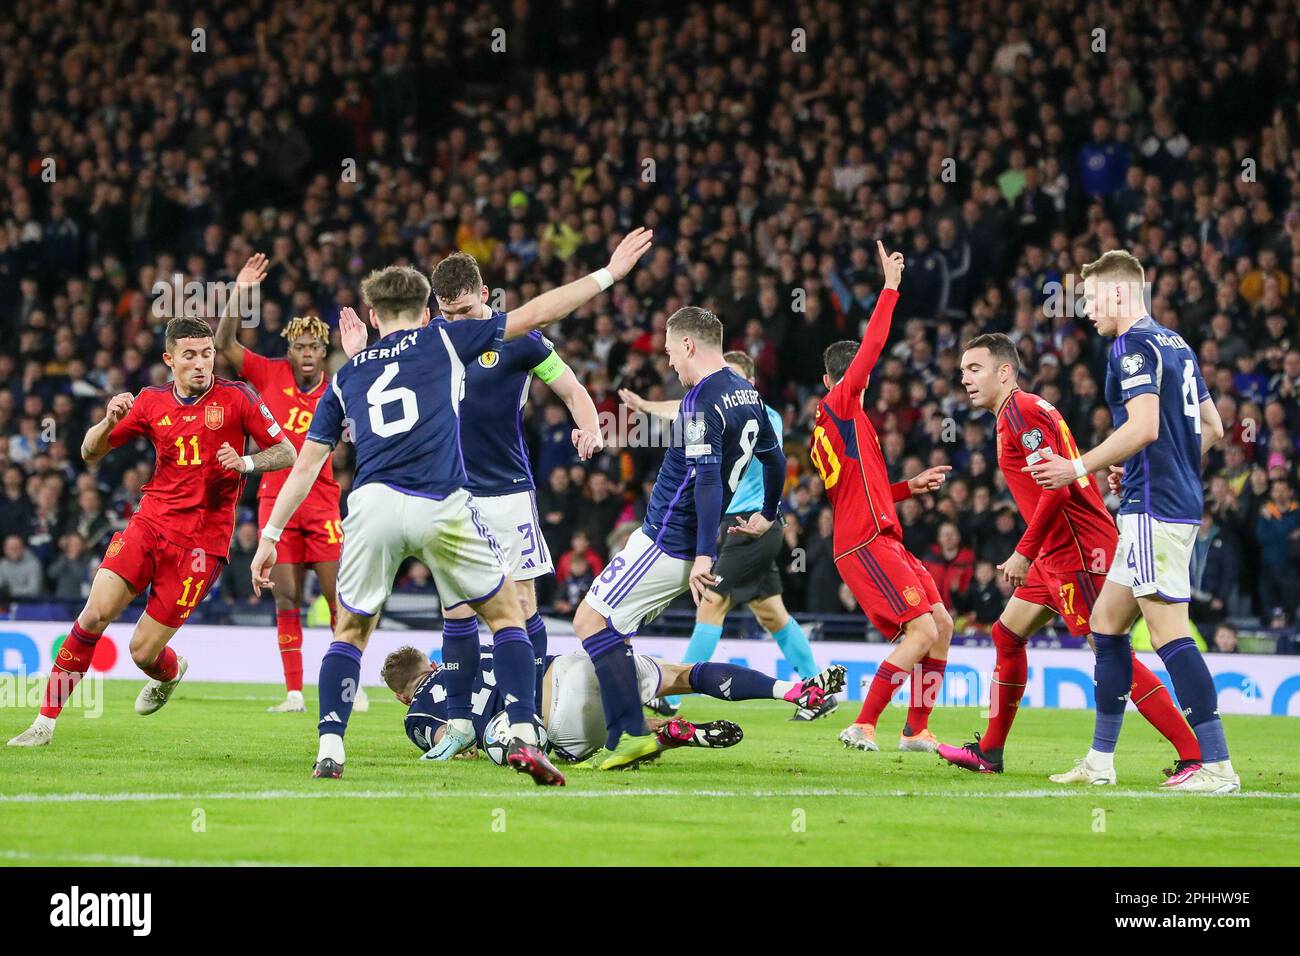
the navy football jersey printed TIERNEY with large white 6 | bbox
[307,313,506,498]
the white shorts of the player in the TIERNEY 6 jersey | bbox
[338,483,507,618]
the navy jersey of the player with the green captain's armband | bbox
[460,321,566,496]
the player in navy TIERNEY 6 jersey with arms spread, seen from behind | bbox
[252,229,650,786]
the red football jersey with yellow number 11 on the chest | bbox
[108,378,287,558]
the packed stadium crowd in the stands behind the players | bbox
[0,0,1300,642]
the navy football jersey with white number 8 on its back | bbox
[642,367,779,561]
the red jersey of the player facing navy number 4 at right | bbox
[997,389,1119,574]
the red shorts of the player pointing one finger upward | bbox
[836,535,944,641]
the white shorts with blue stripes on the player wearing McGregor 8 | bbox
[582,528,692,635]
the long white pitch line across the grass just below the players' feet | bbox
[0,787,1300,804]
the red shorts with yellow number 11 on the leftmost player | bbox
[100,519,226,627]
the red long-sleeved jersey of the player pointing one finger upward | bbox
[811,289,906,559]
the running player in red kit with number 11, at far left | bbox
[9,317,294,747]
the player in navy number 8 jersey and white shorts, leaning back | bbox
[573,306,827,770]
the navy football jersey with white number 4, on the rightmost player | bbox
[1106,316,1209,524]
